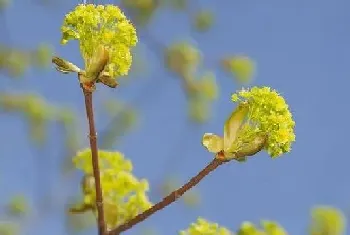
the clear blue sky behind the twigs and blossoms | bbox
[0,0,350,235]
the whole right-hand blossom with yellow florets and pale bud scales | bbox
[202,87,295,160]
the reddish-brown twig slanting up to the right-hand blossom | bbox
[108,155,225,235]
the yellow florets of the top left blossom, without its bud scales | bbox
[61,4,137,77]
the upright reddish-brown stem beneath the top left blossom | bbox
[81,86,106,235]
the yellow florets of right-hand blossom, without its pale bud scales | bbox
[232,87,295,157]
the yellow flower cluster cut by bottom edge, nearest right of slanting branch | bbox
[179,218,233,235]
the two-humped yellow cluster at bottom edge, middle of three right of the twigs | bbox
[237,221,288,235]
